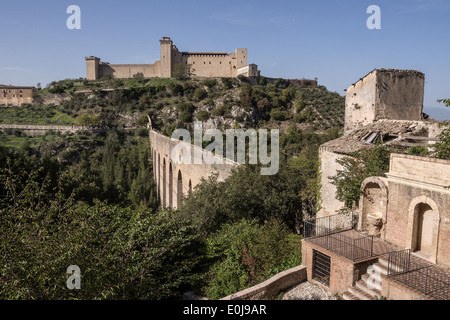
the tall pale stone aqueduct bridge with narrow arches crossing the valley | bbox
[150,129,239,209]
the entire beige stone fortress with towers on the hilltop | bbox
[85,37,258,80]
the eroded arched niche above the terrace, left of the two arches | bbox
[358,177,389,238]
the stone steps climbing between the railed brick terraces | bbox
[342,257,388,300]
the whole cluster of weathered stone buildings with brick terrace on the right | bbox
[302,69,450,300]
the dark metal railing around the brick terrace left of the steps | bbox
[304,214,373,261]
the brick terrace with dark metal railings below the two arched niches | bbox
[304,214,450,300]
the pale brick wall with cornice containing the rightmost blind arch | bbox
[385,154,450,267]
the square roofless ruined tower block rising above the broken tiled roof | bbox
[344,69,425,134]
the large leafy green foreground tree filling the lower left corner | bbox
[0,162,199,300]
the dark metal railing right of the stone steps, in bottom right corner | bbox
[388,249,450,300]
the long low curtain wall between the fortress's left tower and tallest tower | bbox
[99,61,161,79]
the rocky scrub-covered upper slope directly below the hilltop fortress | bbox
[25,77,344,135]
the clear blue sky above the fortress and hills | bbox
[0,0,450,112]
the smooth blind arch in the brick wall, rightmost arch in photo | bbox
[406,195,441,263]
